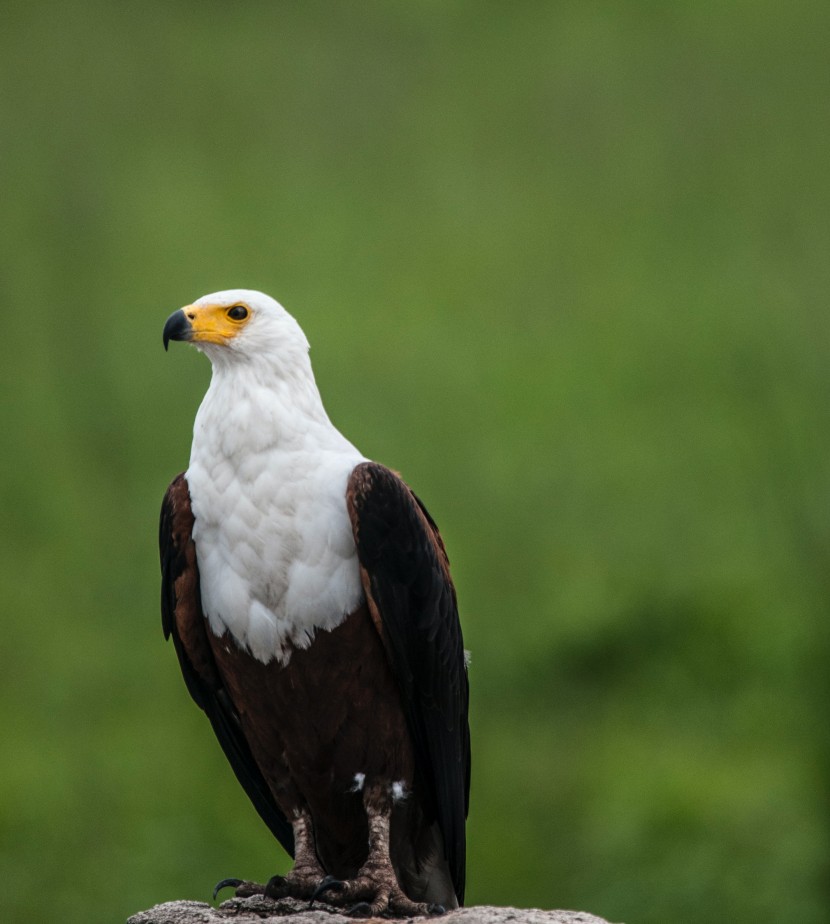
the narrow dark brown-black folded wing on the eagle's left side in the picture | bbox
[159,475,294,856]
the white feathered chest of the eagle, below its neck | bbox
[187,382,363,663]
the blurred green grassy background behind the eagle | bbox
[0,0,830,924]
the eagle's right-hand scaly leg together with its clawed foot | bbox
[314,786,444,917]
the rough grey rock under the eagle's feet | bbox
[127,895,620,924]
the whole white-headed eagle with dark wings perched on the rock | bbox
[159,289,470,916]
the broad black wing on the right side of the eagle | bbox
[347,462,470,904]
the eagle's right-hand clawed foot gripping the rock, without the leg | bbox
[311,865,444,918]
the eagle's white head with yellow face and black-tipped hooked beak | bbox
[163,289,308,368]
